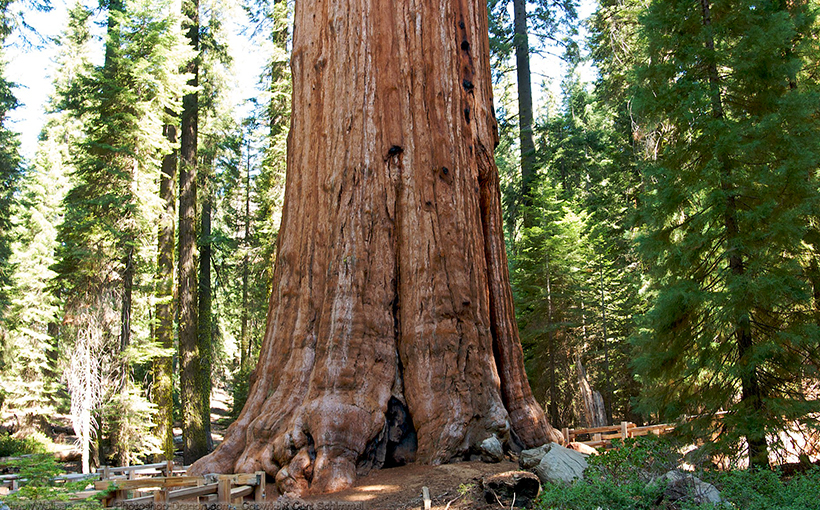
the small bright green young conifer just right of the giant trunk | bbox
[511,178,590,426]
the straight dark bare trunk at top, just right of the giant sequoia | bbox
[513,0,535,228]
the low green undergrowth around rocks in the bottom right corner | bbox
[535,438,820,510]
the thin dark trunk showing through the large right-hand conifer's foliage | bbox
[700,0,769,468]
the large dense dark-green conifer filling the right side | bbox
[635,0,820,466]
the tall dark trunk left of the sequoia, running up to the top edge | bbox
[178,0,210,464]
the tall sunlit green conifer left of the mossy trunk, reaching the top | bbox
[56,0,193,463]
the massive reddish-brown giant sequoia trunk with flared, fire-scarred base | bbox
[191,0,557,494]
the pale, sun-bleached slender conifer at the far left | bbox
[0,0,90,425]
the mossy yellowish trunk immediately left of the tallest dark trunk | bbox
[151,124,177,459]
